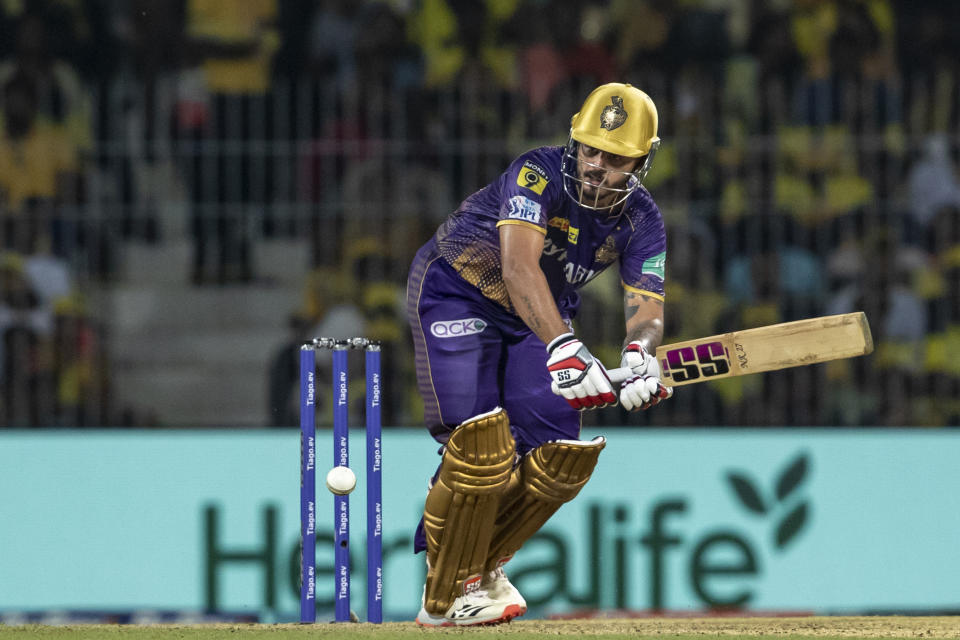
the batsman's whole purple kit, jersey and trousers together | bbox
[407,142,666,551]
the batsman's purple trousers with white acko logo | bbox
[407,243,580,551]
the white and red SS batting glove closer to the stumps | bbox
[547,333,617,409]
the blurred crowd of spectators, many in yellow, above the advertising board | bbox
[0,0,960,426]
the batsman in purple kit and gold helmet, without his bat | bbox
[407,83,671,627]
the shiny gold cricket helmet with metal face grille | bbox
[562,82,660,210]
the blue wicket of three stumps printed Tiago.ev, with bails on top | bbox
[300,338,383,623]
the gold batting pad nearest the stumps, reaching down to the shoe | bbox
[423,408,516,616]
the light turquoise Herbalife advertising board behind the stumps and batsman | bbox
[0,428,960,621]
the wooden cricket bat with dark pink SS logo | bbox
[607,311,873,387]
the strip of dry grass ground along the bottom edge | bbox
[0,616,960,640]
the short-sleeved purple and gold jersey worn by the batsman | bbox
[433,147,666,316]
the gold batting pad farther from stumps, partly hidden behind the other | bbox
[485,437,607,571]
